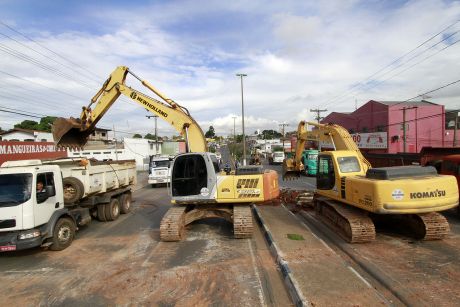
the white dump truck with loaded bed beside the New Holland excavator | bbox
[0,158,137,252]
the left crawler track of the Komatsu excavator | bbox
[315,199,375,243]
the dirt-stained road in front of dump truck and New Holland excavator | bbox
[0,188,290,306]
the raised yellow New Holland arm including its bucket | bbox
[52,66,207,152]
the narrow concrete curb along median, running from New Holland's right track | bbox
[252,205,310,307]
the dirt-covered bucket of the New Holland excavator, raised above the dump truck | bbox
[51,117,93,148]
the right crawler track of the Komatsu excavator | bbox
[403,212,450,241]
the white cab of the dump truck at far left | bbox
[0,160,79,251]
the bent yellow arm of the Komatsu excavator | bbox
[283,121,372,180]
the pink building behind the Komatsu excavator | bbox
[322,100,460,153]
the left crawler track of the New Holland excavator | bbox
[160,206,187,242]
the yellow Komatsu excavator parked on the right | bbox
[283,121,459,243]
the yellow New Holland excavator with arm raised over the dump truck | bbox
[52,66,279,241]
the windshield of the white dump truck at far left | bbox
[0,174,32,207]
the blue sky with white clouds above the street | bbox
[0,0,460,135]
